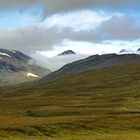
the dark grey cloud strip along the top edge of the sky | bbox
[0,0,140,13]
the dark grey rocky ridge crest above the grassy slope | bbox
[44,54,140,80]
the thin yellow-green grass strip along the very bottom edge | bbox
[1,132,140,140]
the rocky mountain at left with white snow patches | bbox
[0,49,50,85]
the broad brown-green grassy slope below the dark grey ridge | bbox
[0,63,140,140]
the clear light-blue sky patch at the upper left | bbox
[0,6,43,28]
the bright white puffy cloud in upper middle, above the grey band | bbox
[42,10,112,31]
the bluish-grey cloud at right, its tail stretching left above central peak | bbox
[61,15,140,43]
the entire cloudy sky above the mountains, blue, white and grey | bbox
[0,0,140,70]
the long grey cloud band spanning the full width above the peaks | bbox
[0,12,140,53]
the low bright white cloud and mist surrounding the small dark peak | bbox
[31,40,140,71]
